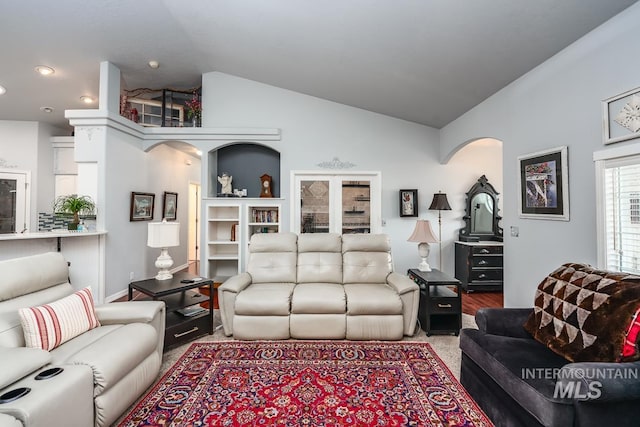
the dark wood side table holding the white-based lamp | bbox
[129,273,214,349]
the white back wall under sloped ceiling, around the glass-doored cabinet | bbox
[202,72,502,274]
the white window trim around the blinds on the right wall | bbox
[593,143,640,269]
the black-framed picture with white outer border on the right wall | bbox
[518,146,569,221]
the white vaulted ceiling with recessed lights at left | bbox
[0,0,637,128]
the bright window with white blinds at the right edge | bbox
[603,156,640,274]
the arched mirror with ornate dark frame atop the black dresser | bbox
[459,175,503,242]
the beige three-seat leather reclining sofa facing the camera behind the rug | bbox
[218,233,420,340]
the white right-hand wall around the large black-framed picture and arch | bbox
[441,4,640,307]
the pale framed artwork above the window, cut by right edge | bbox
[602,88,640,144]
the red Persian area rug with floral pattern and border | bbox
[119,341,492,427]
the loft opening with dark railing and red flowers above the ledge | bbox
[120,86,202,127]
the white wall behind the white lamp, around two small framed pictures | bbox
[99,130,200,300]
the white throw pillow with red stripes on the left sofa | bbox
[19,287,100,351]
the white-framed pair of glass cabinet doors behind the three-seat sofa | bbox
[291,172,382,234]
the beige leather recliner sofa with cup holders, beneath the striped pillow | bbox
[0,253,165,427]
